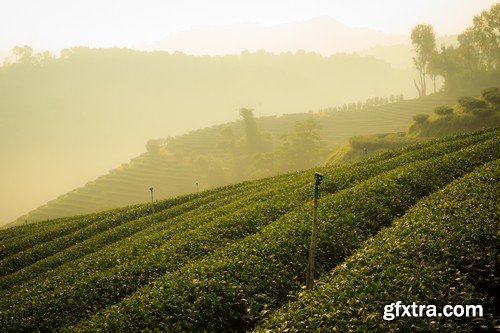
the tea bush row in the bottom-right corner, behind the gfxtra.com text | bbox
[257,160,500,332]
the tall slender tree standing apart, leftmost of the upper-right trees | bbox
[411,24,436,97]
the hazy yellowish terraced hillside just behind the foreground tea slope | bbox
[7,88,477,224]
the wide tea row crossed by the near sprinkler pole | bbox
[71,134,500,331]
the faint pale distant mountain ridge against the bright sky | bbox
[146,16,409,55]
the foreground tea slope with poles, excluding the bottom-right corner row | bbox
[0,126,499,331]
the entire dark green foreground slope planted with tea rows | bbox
[0,128,500,332]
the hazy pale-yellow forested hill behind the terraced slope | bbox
[0,47,414,223]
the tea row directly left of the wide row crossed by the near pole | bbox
[2,177,314,330]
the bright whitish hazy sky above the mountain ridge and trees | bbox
[0,0,497,51]
